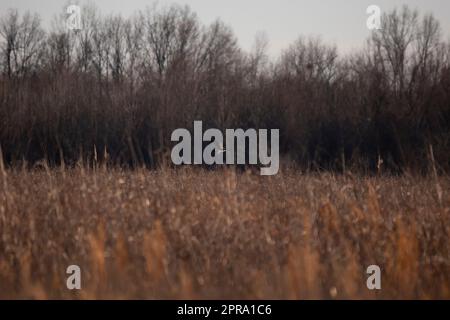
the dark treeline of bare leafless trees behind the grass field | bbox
[0,6,450,172]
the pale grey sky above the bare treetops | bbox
[0,0,450,56]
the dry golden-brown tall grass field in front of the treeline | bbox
[0,167,450,299]
